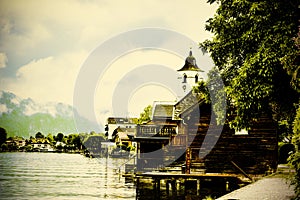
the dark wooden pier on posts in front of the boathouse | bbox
[135,172,242,196]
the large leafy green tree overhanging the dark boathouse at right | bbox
[200,0,299,136]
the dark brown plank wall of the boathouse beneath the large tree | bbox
[183,101,278,174]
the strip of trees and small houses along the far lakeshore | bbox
[0,128,105,153]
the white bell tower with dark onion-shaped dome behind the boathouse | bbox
[177,49,204,94]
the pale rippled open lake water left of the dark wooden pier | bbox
[0,152,136,199]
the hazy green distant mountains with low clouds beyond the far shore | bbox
[0,91,102,137]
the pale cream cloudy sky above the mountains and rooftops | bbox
[0,0,216,128]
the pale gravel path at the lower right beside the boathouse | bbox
[217,177,295,200]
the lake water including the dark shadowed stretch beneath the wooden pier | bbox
[0,152,236,200]
